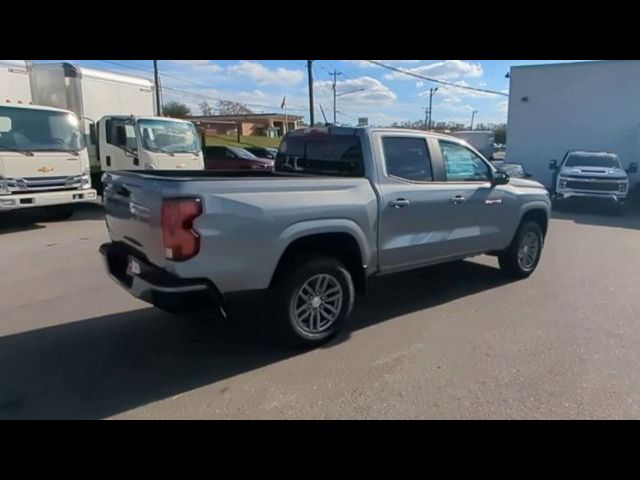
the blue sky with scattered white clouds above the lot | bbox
[35,60,584,125]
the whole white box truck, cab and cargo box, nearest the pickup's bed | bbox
[30,63,204,188]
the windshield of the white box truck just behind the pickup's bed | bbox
[139,119,200,153]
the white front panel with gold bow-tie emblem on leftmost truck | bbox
[0,152,82,178]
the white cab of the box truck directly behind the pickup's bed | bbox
[95,115,204,172]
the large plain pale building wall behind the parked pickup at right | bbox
[506,60,640,191]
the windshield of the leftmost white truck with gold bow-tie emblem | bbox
[0,107,84,152]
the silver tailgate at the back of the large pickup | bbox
[103,172,168,266]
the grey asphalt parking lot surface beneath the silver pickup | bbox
[0,206,640,419]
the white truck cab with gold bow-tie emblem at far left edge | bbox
[0,104,96,218]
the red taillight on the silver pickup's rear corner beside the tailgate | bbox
[162,198,202,262]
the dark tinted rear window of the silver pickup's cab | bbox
[275,134,364,177]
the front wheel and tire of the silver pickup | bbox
[498,221,544,279]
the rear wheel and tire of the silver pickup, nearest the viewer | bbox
[267,256,355,348]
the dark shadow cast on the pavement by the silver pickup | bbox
[0,261,506,419]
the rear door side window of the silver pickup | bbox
[382,137,433,182]
